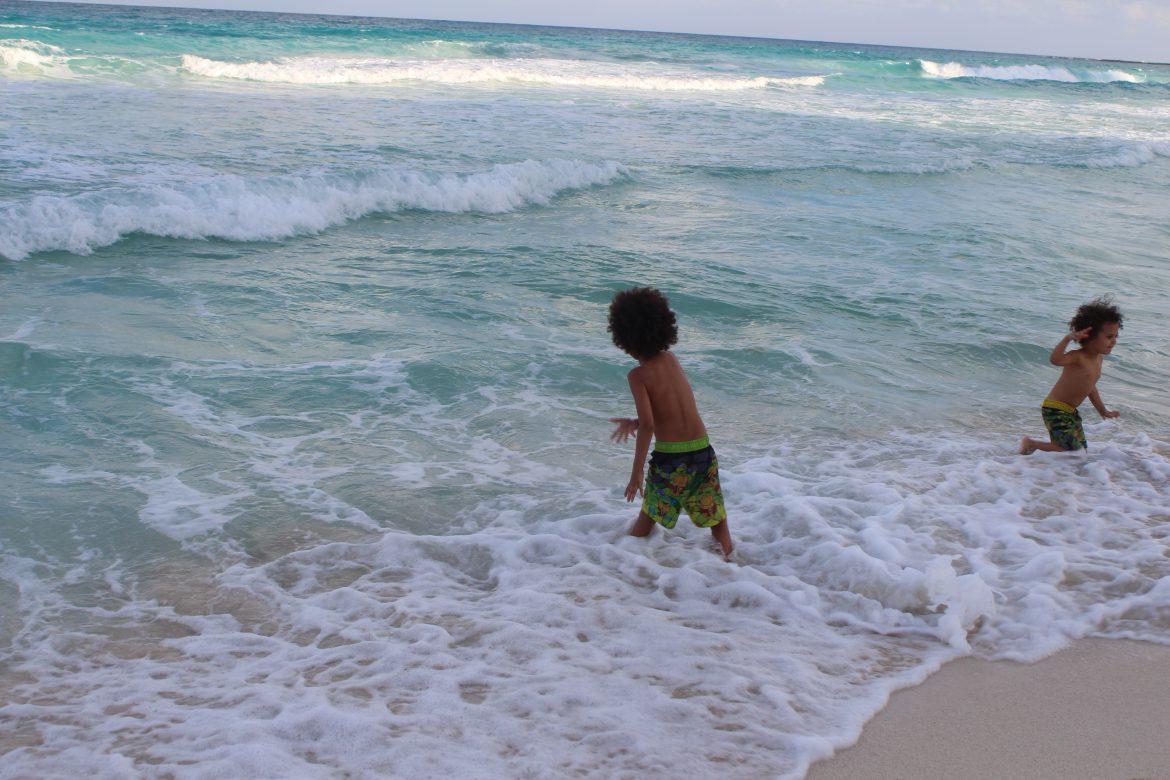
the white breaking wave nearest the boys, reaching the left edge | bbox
[0,159,626,260]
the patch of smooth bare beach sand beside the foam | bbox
[807,640,1170,780]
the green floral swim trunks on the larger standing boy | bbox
[642,436,728,529]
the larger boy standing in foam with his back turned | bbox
[607,288,731,558]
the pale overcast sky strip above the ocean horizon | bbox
[68,0,1170,62]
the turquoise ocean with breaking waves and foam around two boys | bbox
[0,0,1170,779]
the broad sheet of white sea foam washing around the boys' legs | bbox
[0,428,1170,778]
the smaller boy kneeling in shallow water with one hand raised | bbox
[1020,297,1121,455]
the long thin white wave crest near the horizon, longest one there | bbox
[181,54,825,91]
